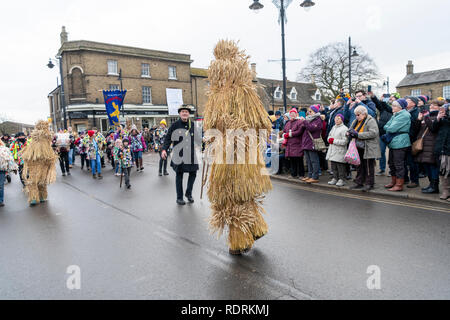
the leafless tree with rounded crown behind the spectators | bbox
[298,42,379,102]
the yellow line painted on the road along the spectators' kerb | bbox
[276,180,450,213]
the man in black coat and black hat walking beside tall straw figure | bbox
[161,105,199,205]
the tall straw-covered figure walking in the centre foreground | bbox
[205,40,272,255]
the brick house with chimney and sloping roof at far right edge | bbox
[397,61,450,99]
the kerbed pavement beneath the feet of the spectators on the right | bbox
[271,168,450,207]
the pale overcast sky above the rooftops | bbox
[0,0,450,124]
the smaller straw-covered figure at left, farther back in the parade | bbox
[21,121,58,206]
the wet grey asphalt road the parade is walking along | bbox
[0,154,450,300]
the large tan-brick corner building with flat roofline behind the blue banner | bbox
[48,27,193,131]
